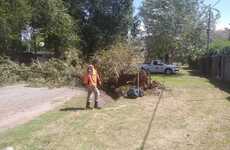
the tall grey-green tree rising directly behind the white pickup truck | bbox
[140,0,218,62]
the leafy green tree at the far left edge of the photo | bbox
[0,0,31,53]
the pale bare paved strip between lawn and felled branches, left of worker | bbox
[0,85,85,132]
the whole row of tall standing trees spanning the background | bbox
[0,0,223,61]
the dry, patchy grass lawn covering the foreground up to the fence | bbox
[0,70,230,150]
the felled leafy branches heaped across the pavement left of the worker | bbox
[0,50,82,87]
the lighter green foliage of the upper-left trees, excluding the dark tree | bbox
[0,0,79,53]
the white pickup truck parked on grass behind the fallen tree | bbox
[141,60,179,74]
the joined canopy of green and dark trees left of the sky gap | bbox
[0,0,133,55]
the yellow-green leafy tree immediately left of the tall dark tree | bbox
[32,0,78,56]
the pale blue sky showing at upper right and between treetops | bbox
[134,0,230,30]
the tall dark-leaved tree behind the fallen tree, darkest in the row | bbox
[65,0,133,55]
